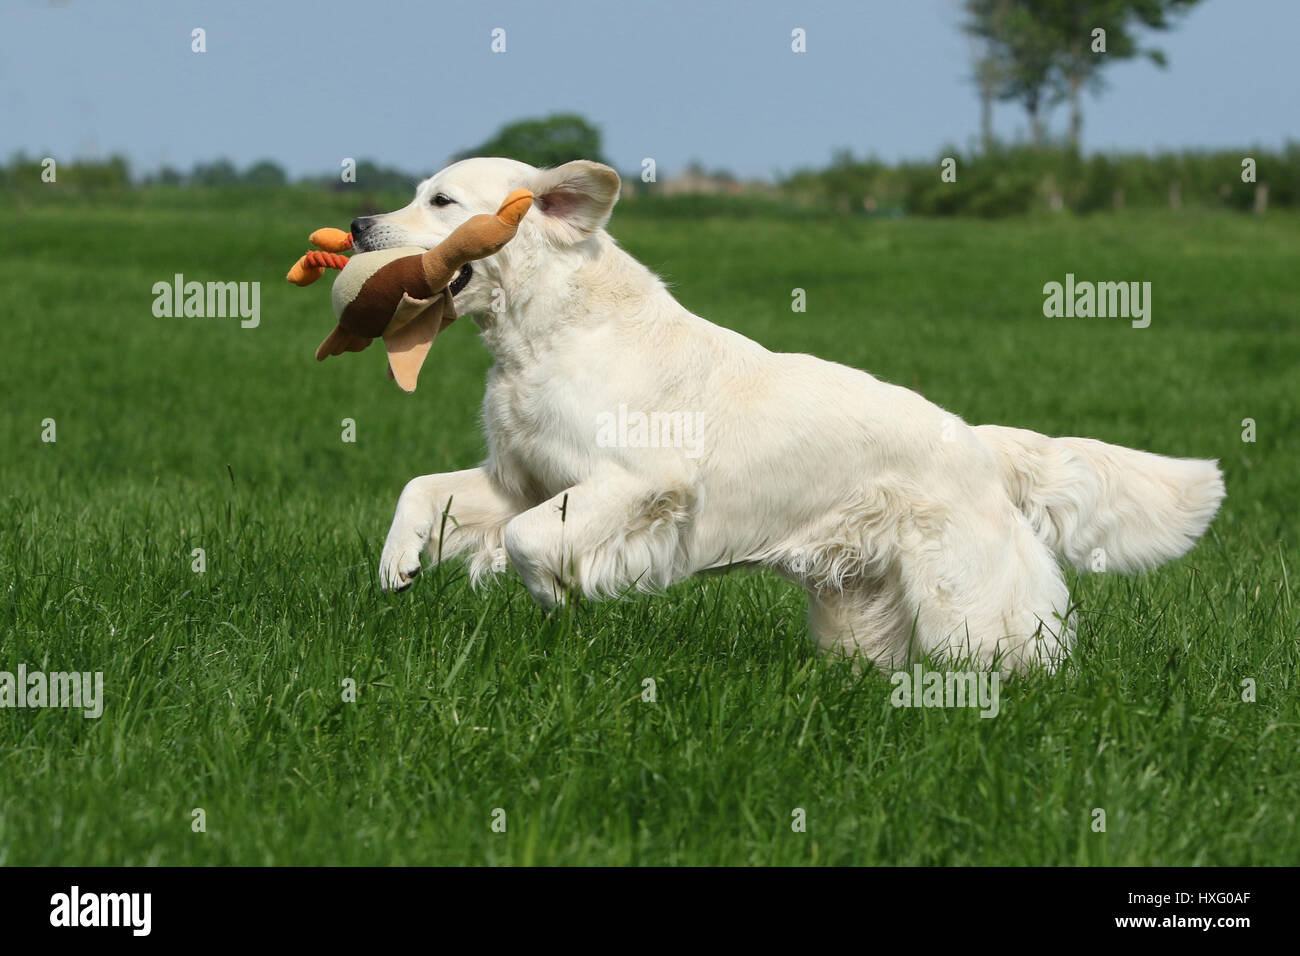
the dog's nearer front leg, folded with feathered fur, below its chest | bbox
[504,473,693,609]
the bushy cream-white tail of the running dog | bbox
[975,425,1225,571]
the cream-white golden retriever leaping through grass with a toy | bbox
[352,159,1223,670]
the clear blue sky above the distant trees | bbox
[0,0,1300,178]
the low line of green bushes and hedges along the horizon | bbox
[0,102,1300,217]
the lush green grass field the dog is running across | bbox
[0,191,1300,865]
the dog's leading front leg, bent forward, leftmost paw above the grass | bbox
[380,468,527,591]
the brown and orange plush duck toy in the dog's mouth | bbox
[286,189,533,392]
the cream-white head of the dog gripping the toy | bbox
[352,157,619,315]
